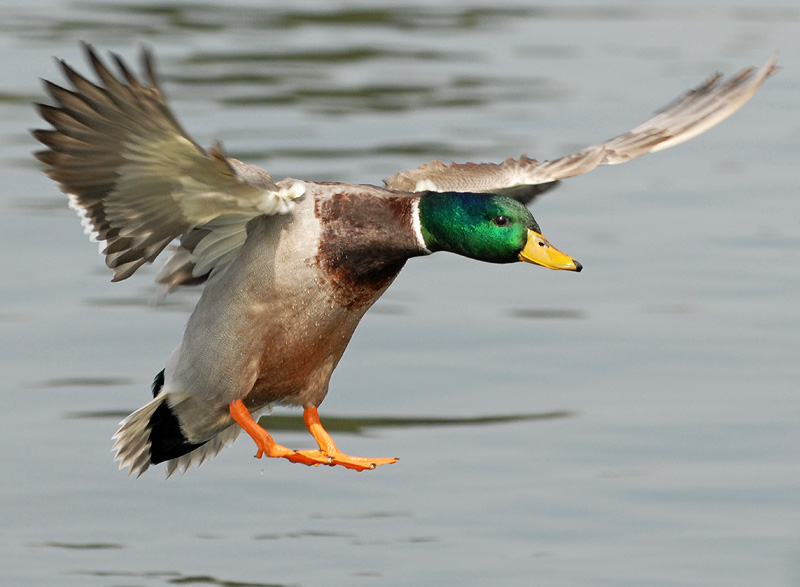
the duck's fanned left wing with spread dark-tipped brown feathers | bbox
[33,45,302,282]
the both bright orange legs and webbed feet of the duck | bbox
[230,400,397,471]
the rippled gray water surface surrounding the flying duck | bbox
[0,0,800,586]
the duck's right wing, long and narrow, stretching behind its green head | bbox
[384,55,777,199]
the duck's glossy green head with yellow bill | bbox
[419,192,582,271]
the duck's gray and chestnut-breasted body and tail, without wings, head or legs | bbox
[115,185,424,473]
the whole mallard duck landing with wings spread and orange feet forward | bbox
[33,45,776,475]
